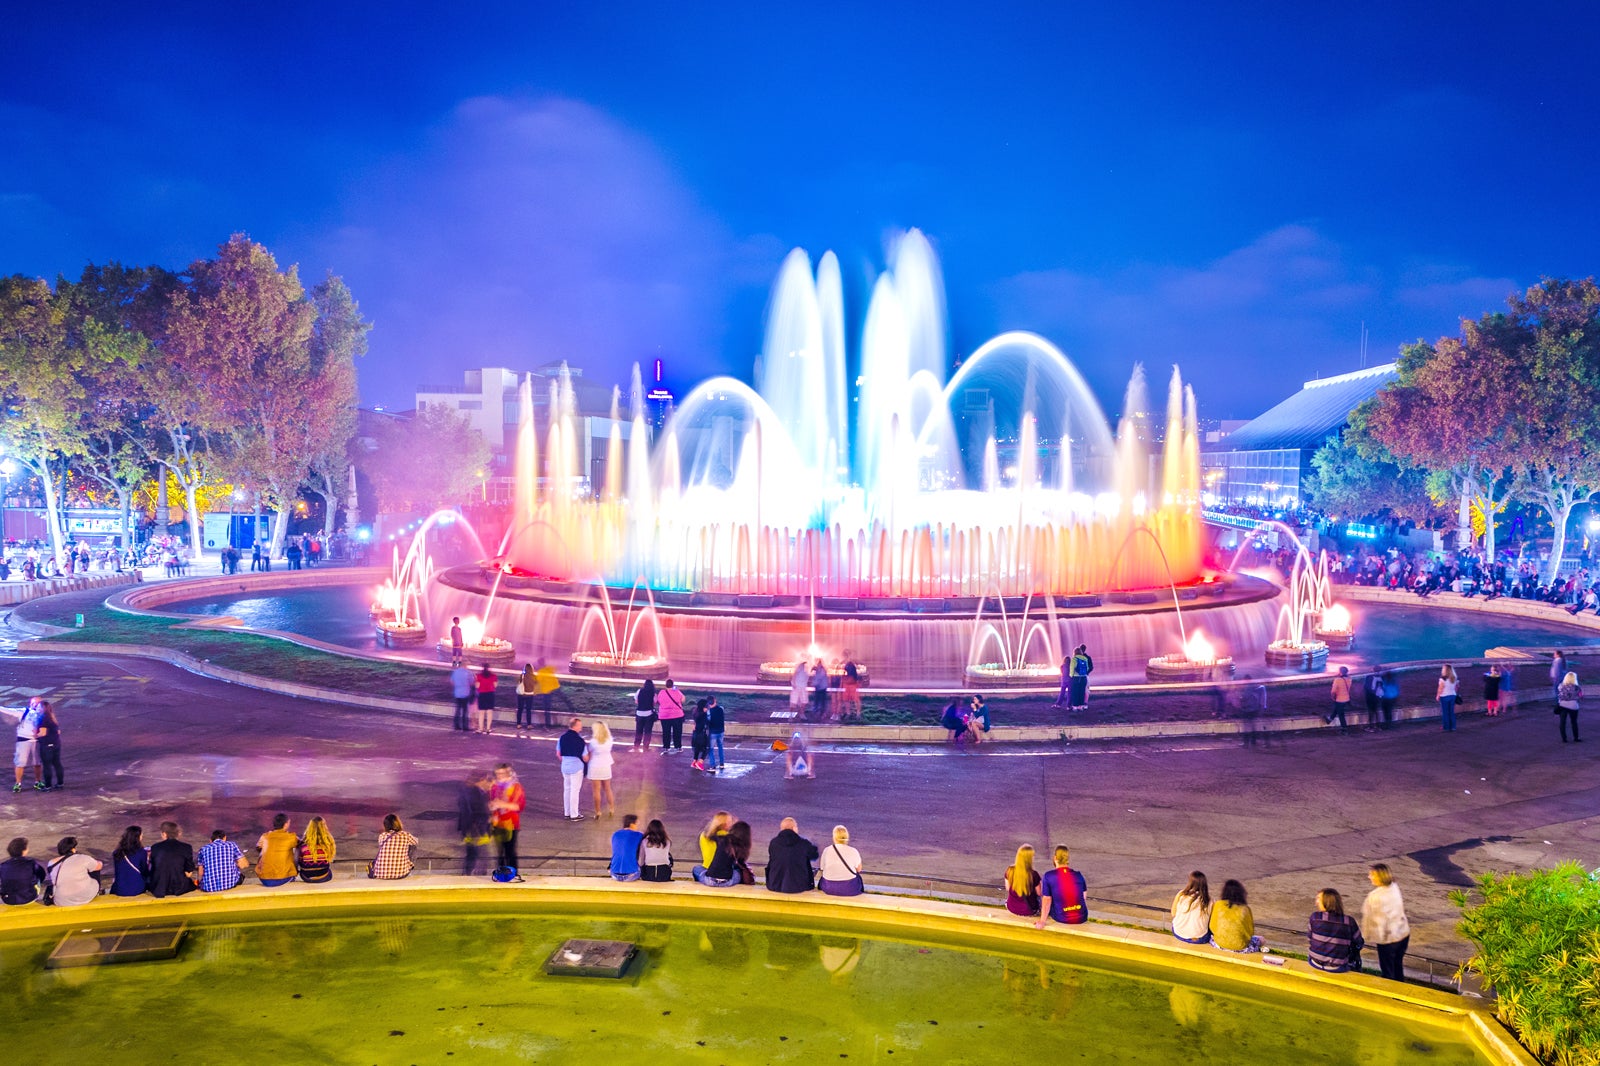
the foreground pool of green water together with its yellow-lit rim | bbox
[0,882,1520,1066]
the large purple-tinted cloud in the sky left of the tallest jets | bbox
[310,98,781,403]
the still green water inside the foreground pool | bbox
[0,914,1480,1066]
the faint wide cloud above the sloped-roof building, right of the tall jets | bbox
[986,224,1515,418]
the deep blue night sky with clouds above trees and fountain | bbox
[0,2,1600,418]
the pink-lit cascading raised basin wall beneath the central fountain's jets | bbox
[424,563,1280,690]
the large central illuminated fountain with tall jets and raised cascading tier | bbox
[427,230,1277,687]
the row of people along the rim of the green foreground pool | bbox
[0,797,1410,981]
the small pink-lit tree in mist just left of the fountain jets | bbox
[366,407,490,514]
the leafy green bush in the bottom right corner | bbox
[1450,863,1600,1066]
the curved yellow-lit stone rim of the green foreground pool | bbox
[0,877,1538,1066]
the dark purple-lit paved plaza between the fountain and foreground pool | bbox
[0,640,1600,962]
